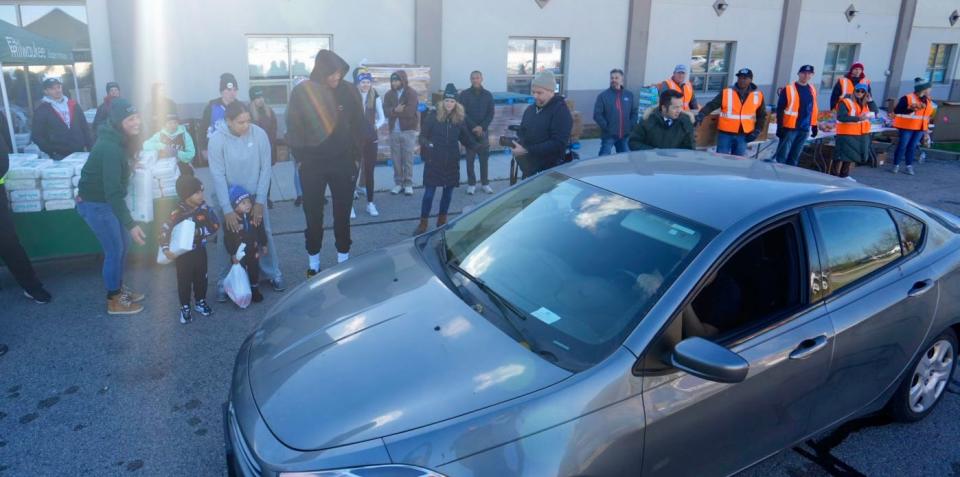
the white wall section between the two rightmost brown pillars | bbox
[793,0,900,106]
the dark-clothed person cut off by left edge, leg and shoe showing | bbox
[0,141,51,302]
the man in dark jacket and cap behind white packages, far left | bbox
[30,78,93,161]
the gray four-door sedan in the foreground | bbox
[226,151,960,477]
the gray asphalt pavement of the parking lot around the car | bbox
[0,155,960,477]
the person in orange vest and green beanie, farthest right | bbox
[891,78,934,176]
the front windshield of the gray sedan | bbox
[443,173,712,368]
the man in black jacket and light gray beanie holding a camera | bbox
[513,70,573,178]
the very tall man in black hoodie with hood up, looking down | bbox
[287,50,368,277]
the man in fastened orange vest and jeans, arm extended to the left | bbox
[696,68,767,156]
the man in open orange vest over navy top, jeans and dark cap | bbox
[776,65,820,166]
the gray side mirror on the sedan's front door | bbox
[670,337,750,383]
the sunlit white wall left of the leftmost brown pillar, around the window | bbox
[109,0,414,110]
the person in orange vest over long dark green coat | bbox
[830,83,877,177]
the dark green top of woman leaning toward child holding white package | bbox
[77,123,134,229]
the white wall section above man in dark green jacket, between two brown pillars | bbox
[644,0,783,95]
